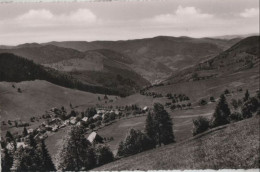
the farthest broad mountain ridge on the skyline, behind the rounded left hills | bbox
[45,36,240,83]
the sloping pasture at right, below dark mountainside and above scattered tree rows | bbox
[149,68,259,103]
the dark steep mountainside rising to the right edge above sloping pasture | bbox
[164,36,260,83]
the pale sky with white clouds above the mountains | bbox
[0,0,259,45]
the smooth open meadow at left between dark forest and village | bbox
[0,80,115,134]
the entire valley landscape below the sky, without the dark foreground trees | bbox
[0,36,260,170]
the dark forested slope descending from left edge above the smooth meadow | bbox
[0,53,126,96]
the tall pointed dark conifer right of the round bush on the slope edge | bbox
[212,94,230,127]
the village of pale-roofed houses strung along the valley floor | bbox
[3,105,149,151]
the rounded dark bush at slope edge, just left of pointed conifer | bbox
[192,116,210,136]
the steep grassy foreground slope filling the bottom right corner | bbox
[94,116,260,170]
